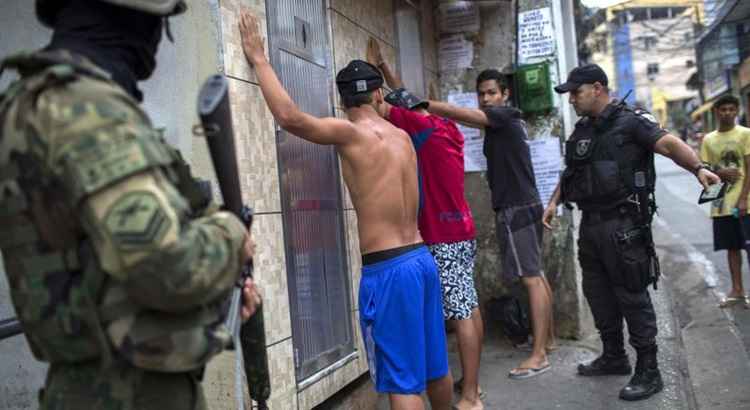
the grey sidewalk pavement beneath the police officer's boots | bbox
[434,250,693,410]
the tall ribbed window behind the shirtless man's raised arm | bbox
[266,0,354,382]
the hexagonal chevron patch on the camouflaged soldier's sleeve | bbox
[104,191,171,250]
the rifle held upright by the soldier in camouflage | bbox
[198,75,271,410]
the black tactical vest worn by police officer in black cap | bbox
[561,106,656,211]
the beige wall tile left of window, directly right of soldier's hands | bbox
[253,214,292,345]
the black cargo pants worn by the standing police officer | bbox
[578,212,656,354]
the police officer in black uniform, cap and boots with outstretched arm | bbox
[543,64,719,400]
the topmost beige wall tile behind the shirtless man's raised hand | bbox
[220,0,268,83]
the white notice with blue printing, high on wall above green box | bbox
[518,7,555,64]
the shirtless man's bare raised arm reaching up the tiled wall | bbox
[240,9,356,145]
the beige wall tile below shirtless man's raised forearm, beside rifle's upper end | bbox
[229,78,281,213]
